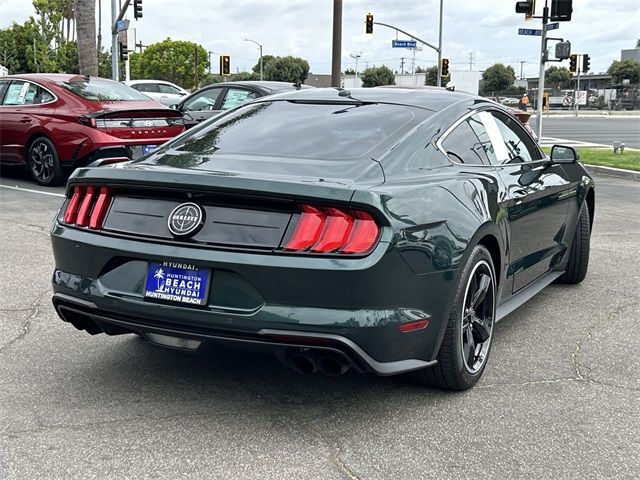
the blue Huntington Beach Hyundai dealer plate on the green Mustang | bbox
[144,261,211,305]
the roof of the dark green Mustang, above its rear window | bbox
[255,88,489,111]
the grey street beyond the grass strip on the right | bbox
[530,116,640,148]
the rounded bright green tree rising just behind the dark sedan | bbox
[136,38,209,89]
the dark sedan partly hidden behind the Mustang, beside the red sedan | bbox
[177,81,313,128]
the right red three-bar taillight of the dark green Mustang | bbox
[284,205,380,254]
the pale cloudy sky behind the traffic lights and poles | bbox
[0,0,640,77]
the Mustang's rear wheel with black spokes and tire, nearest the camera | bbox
[416,245,496,391]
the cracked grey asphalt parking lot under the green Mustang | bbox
[0,171,640,479]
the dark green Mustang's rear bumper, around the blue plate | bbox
[52,223,455,375]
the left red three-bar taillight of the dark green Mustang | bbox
[62,186,112,230]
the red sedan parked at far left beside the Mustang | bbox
[0,74,184,185]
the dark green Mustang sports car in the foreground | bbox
[51,88,595,390]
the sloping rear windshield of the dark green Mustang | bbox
[166,101,430,159]
